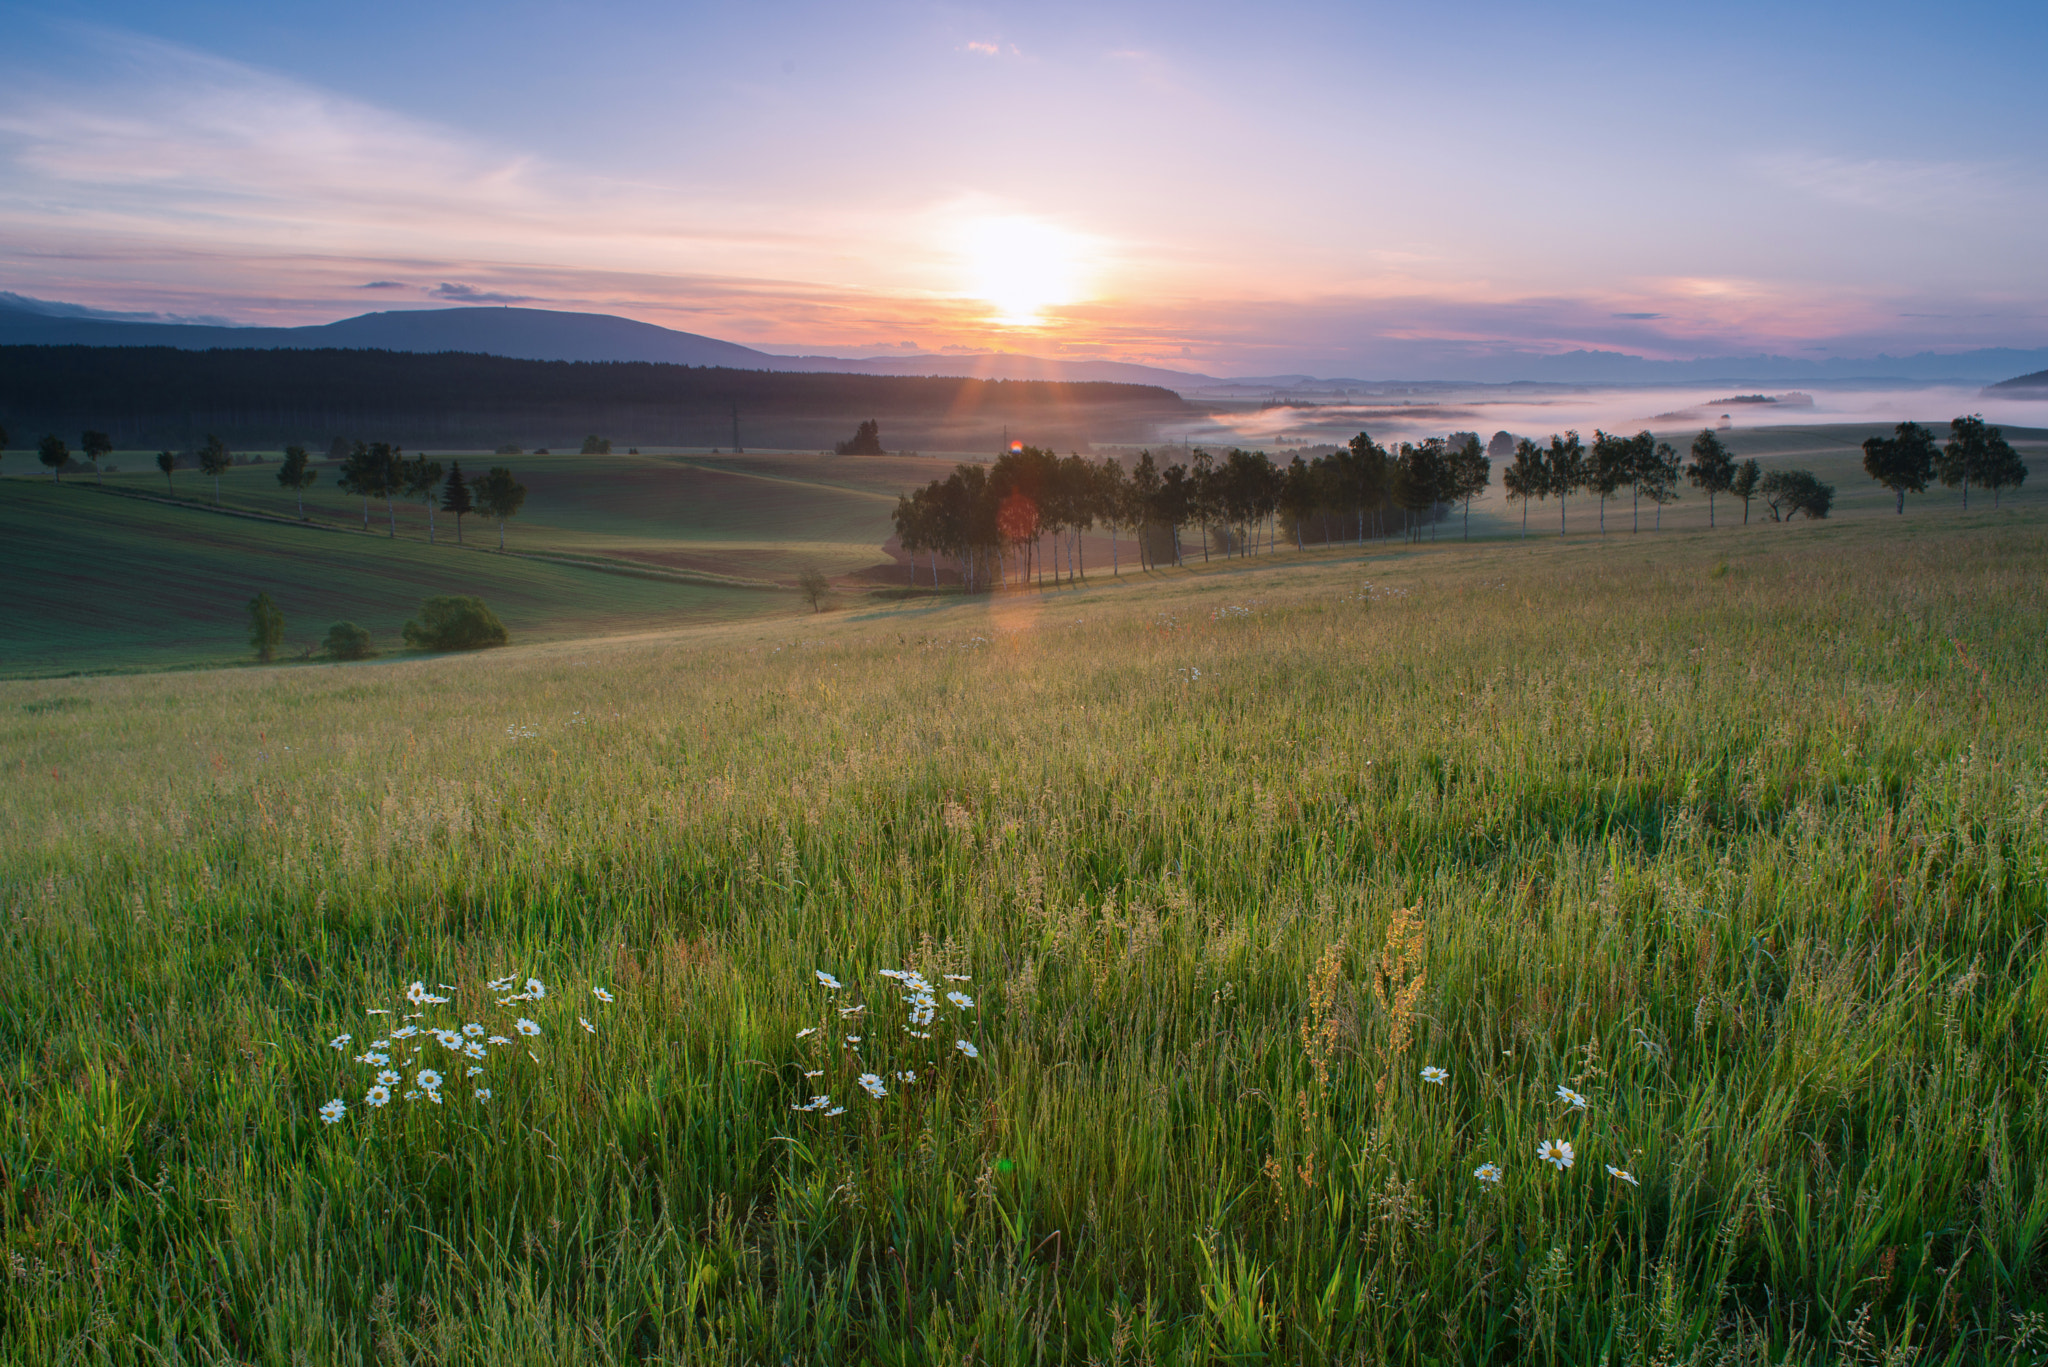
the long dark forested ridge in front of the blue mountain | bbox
[0,346,1188,451]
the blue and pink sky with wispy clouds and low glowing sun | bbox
[0,0,2048,377]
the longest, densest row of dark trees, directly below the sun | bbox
[895,432,1491,588]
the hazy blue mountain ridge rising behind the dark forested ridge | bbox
[0,293,1210,387]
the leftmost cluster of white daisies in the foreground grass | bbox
[319,974,614,1125]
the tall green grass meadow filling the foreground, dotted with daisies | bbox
[0,500,2048,1365]
